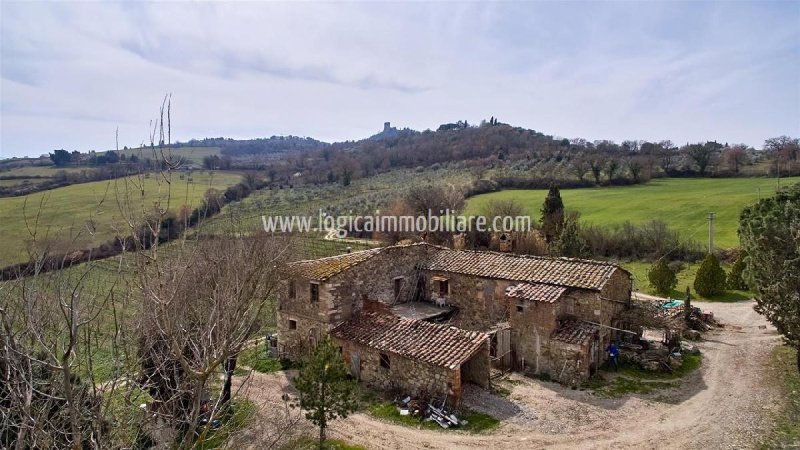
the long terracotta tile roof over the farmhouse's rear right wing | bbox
[420,250,624,290]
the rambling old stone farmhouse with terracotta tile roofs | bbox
[277,243,631,401]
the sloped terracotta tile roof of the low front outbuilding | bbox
[331,312,489,369]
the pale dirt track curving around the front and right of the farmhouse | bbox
[236,302,779,449]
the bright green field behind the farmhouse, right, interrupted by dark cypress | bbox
[467,177,800,248]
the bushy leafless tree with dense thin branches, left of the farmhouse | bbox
[137,235,287,447]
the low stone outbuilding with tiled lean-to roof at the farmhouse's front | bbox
[330,312,490,402]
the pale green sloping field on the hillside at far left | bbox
[0,171,241,266]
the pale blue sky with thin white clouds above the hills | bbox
[0,1,800,158]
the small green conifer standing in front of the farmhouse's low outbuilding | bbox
[295,338,357,447]
